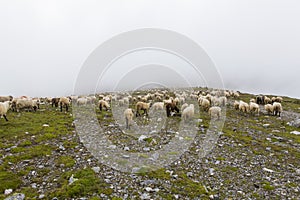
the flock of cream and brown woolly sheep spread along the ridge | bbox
[0,89,283,129]
